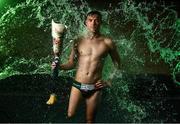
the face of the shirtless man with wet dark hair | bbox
[85,15,101,32]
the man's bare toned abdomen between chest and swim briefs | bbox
[75,57,103,84]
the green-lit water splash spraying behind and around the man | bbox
[0,0,180,122]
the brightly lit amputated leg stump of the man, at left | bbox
[68,86,82,115]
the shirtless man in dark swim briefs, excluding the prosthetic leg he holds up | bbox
[53,11,120,123]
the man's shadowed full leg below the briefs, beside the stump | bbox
[86,90,102,120]
